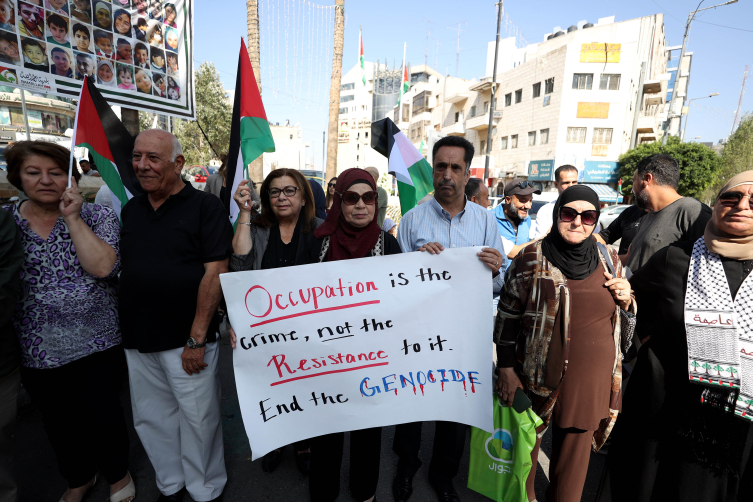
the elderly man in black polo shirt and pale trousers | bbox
[119,129,233,502]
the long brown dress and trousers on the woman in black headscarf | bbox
[533,267,615,502]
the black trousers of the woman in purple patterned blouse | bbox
[21,346,129,488]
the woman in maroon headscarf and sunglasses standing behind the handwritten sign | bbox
[309,169,400,502]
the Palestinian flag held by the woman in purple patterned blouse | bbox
[71,77,144,218]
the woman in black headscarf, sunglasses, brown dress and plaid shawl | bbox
[494,185,636,502]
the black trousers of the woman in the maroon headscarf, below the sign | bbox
[309,427,382,502]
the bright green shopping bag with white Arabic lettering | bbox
[468,395,543,502]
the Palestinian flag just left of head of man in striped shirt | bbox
[371,119,434,214]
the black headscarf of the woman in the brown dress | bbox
[541,185,599,280]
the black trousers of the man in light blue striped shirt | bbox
[392,421,468,487]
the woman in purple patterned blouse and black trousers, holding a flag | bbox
[5,141,136,502]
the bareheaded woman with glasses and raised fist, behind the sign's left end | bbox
[228,169,322,475]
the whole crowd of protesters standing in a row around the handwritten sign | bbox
[0,130,753,502]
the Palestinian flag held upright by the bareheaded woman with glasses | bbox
[222,38,275,228]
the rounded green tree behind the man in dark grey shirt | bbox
[619,136,723,202]
